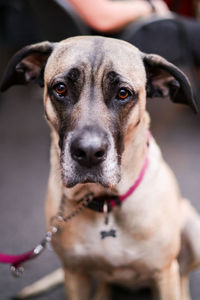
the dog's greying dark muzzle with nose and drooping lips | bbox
[60,125,120,187]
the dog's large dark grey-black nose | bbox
[71,128,108,168]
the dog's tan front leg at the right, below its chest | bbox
[154,260,181,300]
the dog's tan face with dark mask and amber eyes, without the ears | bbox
[45,38,146,186]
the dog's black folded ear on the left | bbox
[1,42,54,91]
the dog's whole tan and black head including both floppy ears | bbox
[2,37,196,187]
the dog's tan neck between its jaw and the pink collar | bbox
[50,113,149,201]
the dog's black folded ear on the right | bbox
[142,54,200,112]
